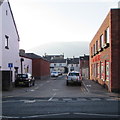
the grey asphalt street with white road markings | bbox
[2,75,120,119]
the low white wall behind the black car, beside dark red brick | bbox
[18,57,32,74]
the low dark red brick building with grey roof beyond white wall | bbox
[20,50,50,79]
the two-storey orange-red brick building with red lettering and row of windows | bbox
[90,9,120,92]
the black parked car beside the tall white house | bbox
[15,73,35,87]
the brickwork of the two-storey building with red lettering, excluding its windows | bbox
[90,9,120,91]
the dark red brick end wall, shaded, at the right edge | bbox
[111,9,120,91]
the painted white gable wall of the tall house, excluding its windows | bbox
[0,0,20,82]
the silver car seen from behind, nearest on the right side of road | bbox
[66,71,82,86]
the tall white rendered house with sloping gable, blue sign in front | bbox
[0,0,20,85]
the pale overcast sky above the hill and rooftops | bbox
[9,0,119,50]
